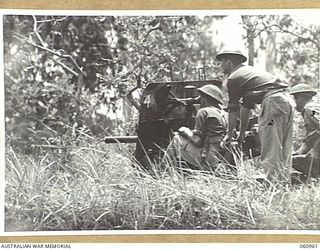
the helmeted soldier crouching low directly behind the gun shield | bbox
[169,84,227,169]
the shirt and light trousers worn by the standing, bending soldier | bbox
[227,64,294,182]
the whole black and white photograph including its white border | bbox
[1,10,320,233]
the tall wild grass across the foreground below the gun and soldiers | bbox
[5,134,320,231]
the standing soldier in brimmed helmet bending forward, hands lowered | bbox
[216,50,294,182]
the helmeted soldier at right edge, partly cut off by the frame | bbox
[290,83,320,179]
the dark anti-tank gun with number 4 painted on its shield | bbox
[104,80,259,170]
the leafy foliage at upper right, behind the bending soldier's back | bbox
[243,15,320,87]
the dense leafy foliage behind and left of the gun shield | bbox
[4,16,222,152]
